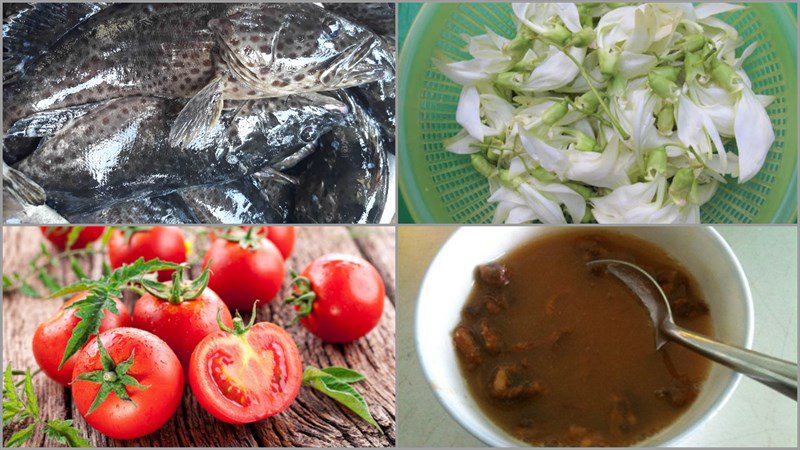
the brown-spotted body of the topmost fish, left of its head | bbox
[3,3,227,131]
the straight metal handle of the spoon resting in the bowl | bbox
[665,326,797,401]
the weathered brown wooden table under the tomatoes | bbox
[2,227,396,447]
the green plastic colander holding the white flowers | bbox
[398,3,798,223]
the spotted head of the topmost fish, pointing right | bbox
[209,3,394,96]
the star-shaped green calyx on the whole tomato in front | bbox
[76,336,150,416]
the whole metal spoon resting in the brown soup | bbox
[587,259,797,400]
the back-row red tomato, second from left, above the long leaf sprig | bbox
[108,227,186,281]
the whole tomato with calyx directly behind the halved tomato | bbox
[133,272,233,370]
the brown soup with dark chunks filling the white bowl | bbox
[453,230,712,446]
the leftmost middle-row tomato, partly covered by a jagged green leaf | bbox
[33,292,131,386]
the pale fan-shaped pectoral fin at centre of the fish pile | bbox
[169,74,228,148]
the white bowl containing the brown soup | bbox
[415,226,753,447]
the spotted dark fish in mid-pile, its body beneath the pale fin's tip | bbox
[16,94,348,215]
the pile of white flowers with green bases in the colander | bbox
[435,3,775,223]
